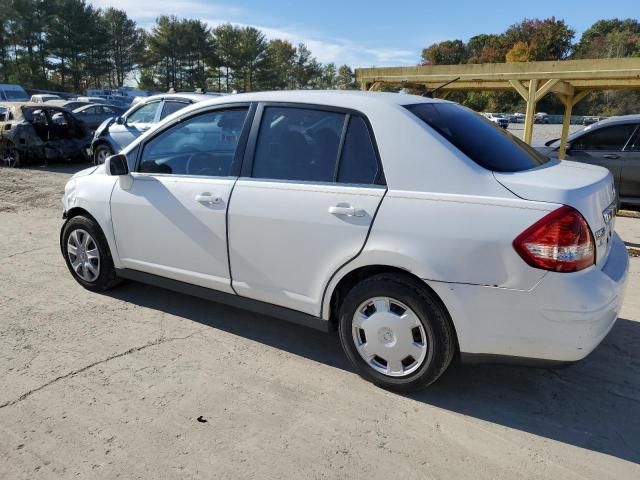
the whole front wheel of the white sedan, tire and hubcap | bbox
[61,216,121,291]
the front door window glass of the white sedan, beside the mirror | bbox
[138,108,247,177]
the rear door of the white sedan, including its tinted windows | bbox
[228,104,386,315]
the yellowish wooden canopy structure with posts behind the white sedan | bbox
[355,58,640,158]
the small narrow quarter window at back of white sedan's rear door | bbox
[338,116,378,184]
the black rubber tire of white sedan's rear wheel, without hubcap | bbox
[339,273,456,392]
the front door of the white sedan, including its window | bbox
[111,105,249,293]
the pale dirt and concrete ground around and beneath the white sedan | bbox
[0,163,640,480]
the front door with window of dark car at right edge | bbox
[566,124,635,192]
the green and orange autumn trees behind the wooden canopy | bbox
[420,17,640,115]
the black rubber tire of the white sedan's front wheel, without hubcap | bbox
[60,215,122,292]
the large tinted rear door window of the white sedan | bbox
[252,107,346,182]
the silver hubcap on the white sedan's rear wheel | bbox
[352,297,428,377]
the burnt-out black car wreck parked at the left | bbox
[0,102,91,167]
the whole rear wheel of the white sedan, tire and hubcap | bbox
[339,273,456,391]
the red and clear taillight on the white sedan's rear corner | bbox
[513,205,595,272]
